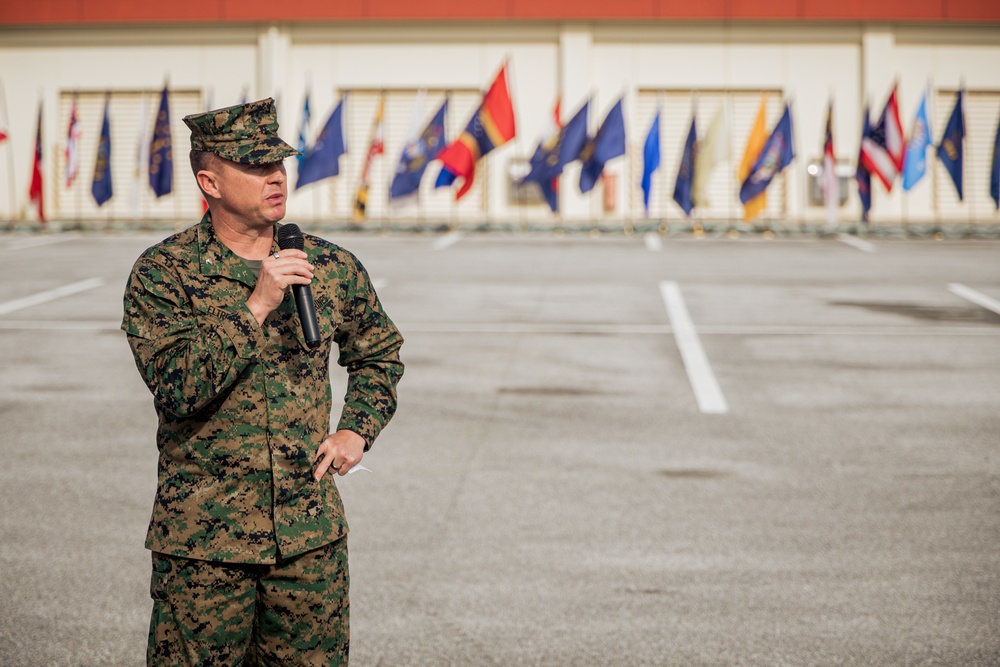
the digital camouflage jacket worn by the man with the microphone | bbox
[122,214,403,563]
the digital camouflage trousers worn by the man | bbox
[146,537,350,667]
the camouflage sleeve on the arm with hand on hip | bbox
[335,257,403,450]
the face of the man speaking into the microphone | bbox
[214,159,288,227]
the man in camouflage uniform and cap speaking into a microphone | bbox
[122,99,403,666]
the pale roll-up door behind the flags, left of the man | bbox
[56,90,205,226]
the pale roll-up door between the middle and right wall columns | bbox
[629,90,786,222]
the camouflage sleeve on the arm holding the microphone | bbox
[122,257,267,417]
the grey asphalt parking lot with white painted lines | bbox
[0,228,1000,667]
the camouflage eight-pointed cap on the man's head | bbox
[184,97,300,164]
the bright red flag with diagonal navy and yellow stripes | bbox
[438,63,517,199]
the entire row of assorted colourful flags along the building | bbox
[11,70,1000,223]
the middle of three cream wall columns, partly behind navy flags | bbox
[559,25,599,220]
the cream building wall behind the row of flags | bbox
[0,22,1000,224]
